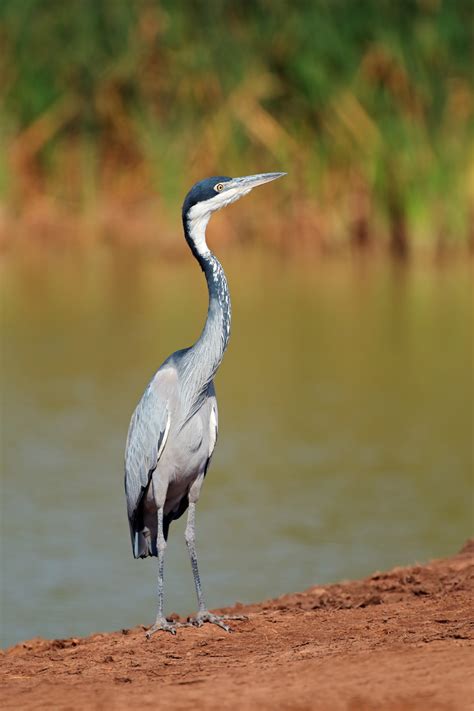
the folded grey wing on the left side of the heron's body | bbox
[125,365,177,523]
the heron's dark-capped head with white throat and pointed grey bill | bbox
[183,173,286,254]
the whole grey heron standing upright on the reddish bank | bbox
[125,173,285,638]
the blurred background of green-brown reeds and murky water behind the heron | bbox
[0,0,474,644]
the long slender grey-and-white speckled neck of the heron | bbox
[184,217,231,392]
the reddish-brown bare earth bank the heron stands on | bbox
[0,541,474,711]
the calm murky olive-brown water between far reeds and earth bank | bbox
[2,253,472,645]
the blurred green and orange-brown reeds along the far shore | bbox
[0,0,474,255]
